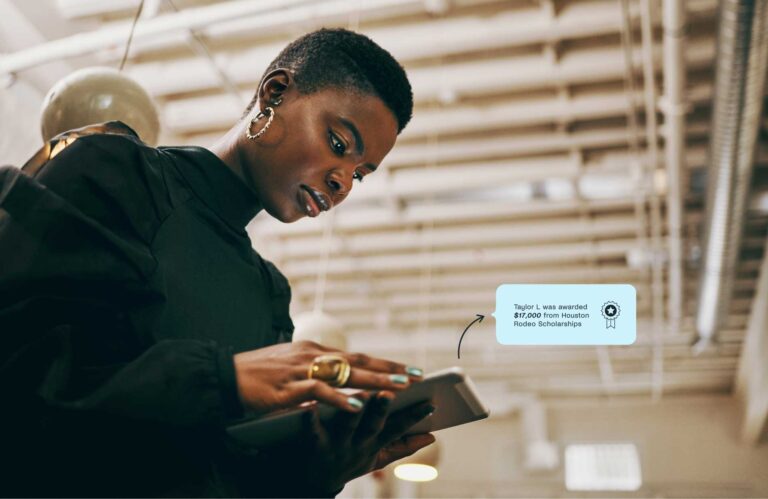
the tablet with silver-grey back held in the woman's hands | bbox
[227,367,490,447]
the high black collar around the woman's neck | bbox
[159,146,261,231]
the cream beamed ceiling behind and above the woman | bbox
[3,0,768,408]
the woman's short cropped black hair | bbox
[244,28,413,134]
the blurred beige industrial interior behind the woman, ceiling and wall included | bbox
[0,0,768,497]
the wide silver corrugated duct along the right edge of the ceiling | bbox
[694,0,768,353]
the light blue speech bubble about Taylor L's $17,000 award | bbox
[492,284,637,345]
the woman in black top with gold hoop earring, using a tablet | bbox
[0,30,434,496]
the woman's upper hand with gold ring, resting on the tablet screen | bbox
[234,341,421,414]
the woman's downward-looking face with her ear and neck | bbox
[238,85,397,222]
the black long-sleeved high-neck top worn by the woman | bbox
[0,125,306,496]
